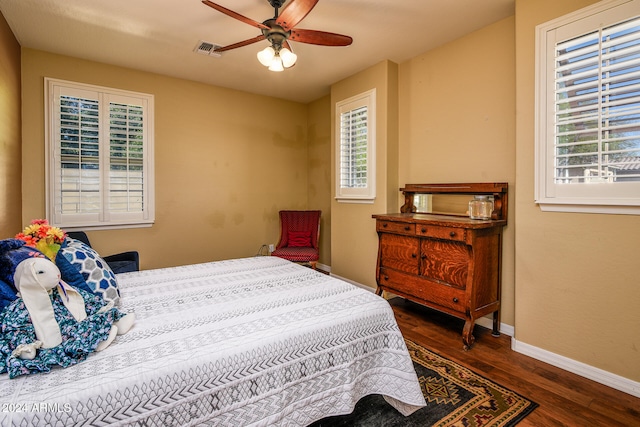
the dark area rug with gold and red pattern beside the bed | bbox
[312,340,538,427]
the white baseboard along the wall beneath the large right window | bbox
[511,339,640,397]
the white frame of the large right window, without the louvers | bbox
[535,0,640,215]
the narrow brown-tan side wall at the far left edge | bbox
[0,14,22,239]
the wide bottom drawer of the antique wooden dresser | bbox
[379,268,468,313]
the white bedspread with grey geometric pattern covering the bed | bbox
[0,256,425,426]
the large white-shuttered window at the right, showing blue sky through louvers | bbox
[536,0,640,214]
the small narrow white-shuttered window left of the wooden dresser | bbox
[336,90,375,203]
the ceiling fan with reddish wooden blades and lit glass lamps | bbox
[202,0,353,71]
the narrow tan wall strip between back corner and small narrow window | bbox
[307,96,331,266]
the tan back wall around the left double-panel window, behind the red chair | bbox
[22,49,314,269]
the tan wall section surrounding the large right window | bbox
[515,0,640,381]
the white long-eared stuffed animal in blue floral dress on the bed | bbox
[0,258,135,378]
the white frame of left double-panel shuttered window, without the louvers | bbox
[44,77,155,231]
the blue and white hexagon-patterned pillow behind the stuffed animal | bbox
[60,237,120,305]
